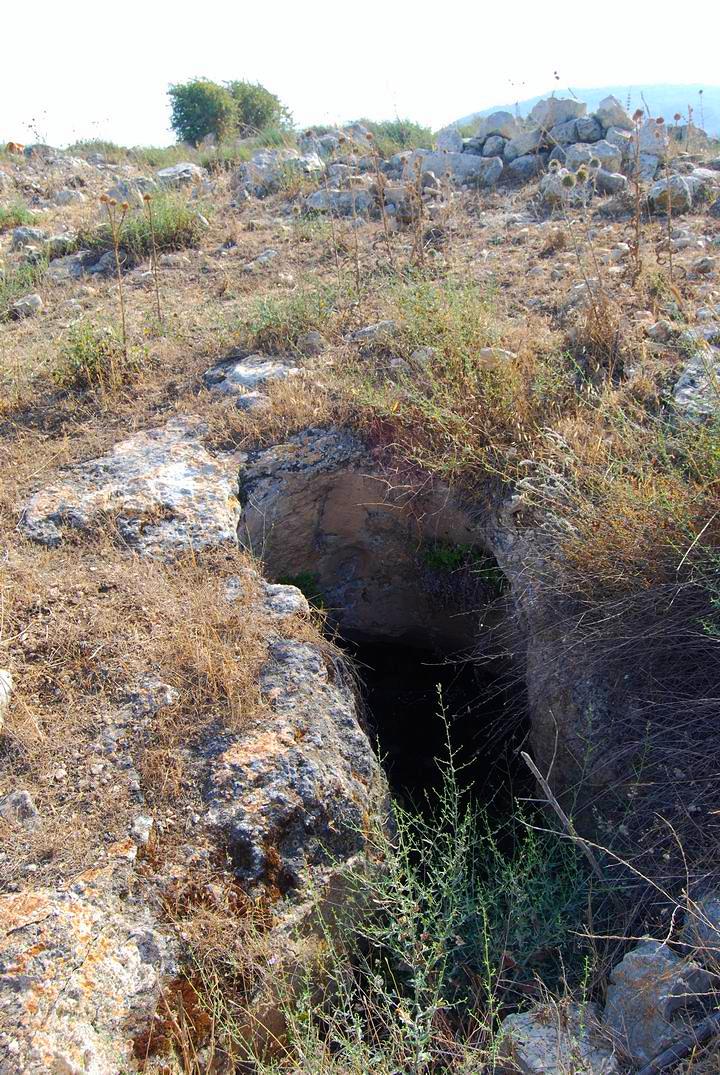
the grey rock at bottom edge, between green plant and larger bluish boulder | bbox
[501,1004,620,1075]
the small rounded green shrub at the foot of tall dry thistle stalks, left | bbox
[53,321,140,391]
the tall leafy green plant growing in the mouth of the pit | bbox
[236,717,590,1075]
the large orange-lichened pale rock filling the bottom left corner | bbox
[0,885,175,1075]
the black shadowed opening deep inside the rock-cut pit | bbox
[345,637,531,817]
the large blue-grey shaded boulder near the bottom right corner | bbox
[604,941,710,1064]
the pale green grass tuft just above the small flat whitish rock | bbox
[240,285,341,354]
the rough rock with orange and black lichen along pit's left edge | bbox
[205,636,387,891]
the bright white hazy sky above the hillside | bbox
[0,0,720,145]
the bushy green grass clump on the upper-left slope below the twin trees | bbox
[76,194,205,267]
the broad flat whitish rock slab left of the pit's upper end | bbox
[20,419,240,556]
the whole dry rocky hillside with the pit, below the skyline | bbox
[0,98,720,1075]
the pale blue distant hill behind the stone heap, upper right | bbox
[453,83,720,138]
